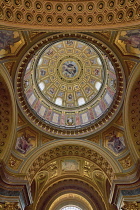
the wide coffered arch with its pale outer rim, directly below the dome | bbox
[20,139,121,181]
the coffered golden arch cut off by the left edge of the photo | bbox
[0,64,17,162]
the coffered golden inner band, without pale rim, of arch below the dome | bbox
[27,145,114,182]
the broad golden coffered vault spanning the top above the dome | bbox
[0,0,140,31]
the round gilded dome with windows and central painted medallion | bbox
[17,33,123,138]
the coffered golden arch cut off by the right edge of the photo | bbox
[124,64,140,161]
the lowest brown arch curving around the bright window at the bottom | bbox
[35,179,106,210]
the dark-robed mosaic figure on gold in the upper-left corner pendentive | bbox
[0,30,20,53]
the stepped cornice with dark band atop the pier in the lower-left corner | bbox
[0,162,32,210]
